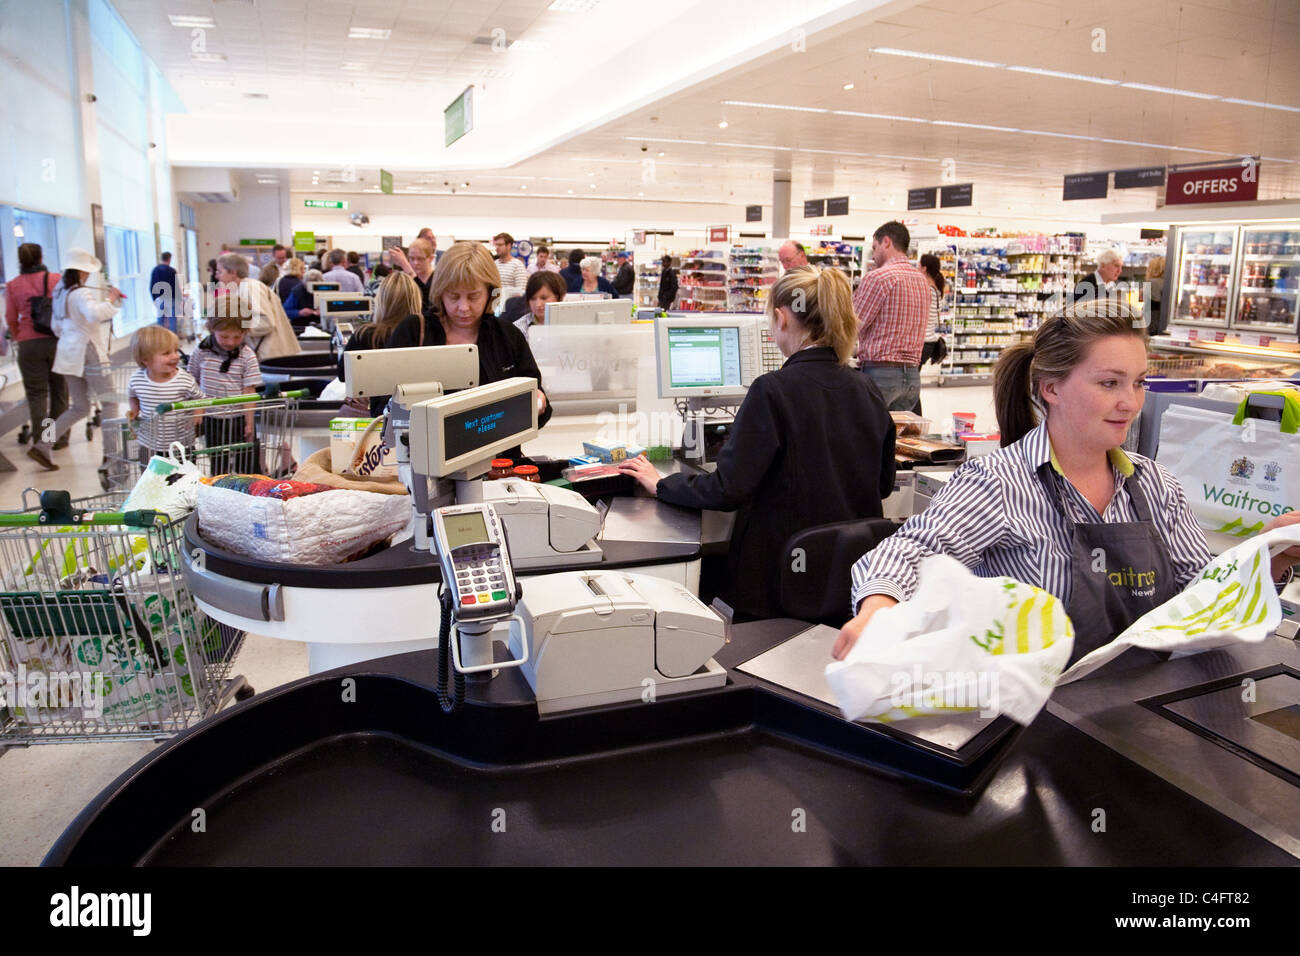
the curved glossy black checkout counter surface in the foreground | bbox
[46,620,1296,865]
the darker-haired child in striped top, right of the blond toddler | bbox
[190,310,261,475]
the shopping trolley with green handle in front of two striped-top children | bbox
[100,389,311,490]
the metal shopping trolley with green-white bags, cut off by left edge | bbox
[0,488,254,747]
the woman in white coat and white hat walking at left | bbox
[36,248,124,467]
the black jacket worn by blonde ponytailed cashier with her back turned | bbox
[658,349,894,618]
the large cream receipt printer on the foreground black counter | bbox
[511,572,727,714]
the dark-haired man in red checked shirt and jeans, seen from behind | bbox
[853,222,931,411]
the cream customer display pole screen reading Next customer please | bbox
[410,378,537,479]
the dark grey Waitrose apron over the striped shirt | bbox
[1039,466,1178,666]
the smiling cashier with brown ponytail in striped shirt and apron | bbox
[832,299,1300,663]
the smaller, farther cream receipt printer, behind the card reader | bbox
[472,479,601,570]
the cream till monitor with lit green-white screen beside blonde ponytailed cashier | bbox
[654,313,766,398]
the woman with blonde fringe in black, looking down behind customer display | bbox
[385,242,551,442]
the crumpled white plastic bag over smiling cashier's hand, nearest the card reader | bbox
[826,554,1074,724]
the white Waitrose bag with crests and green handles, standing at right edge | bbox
[1158,389,1300,537]
